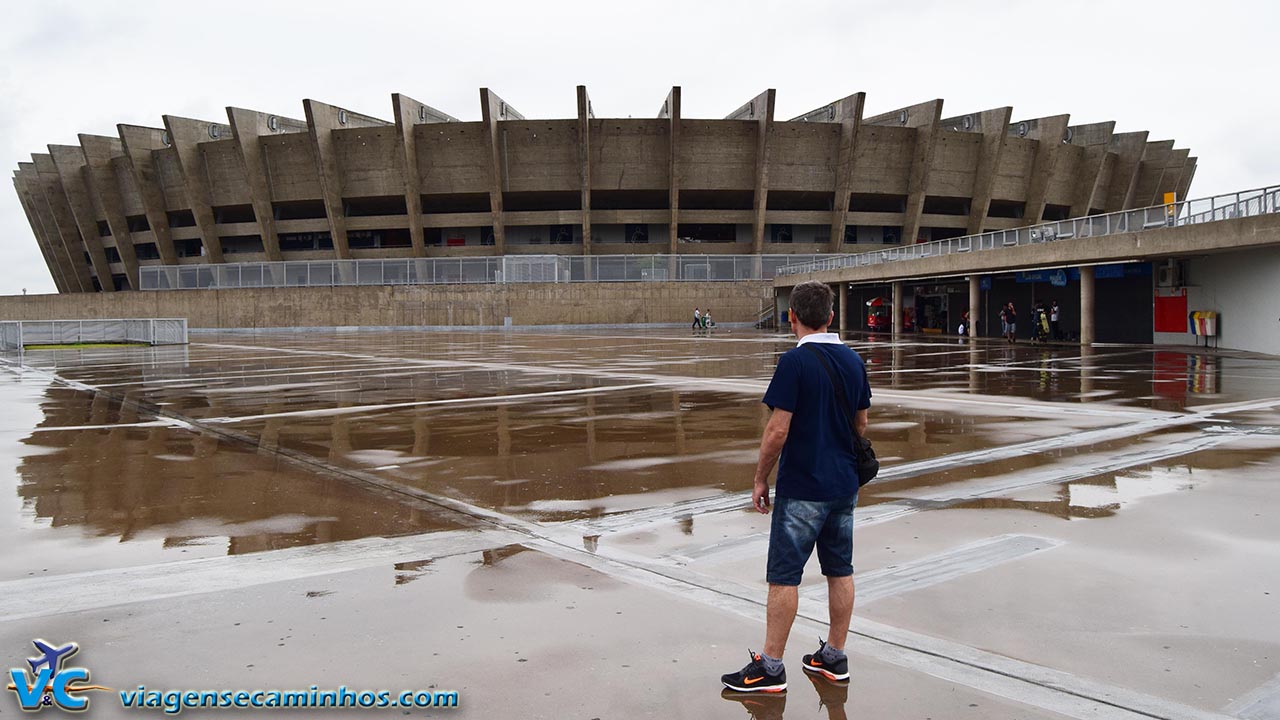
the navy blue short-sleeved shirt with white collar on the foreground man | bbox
[763,333,872,500]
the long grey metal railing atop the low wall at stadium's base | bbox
[138,255,844,290]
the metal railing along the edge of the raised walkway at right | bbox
[777,186,1280,275]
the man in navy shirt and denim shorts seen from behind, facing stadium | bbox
[721,282,872,692]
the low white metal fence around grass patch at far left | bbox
[0,318,187,350]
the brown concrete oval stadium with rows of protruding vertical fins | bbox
[14,86,1196,292]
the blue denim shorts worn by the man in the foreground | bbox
[765,493,858,585]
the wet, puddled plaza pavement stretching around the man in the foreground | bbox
[0,328,1280,719]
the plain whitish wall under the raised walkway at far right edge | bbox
[1155,247,1280,355]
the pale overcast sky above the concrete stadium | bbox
[0,0,1280,295]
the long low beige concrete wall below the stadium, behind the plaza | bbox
[0,281,773,328]
